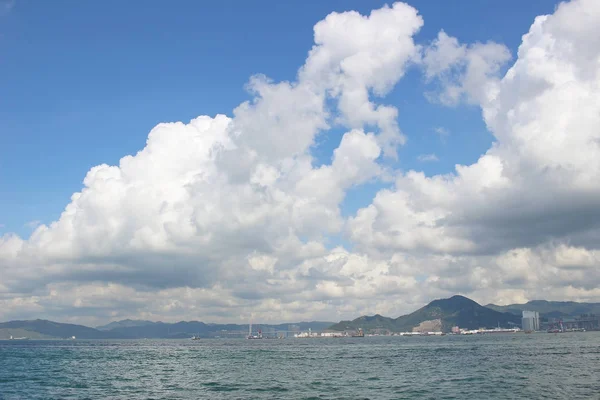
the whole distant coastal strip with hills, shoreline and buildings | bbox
[0,295,600,340]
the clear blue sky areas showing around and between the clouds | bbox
[0,0,555,236]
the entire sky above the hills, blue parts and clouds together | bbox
[0,0,600,325]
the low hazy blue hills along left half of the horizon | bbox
[0,319,332,340]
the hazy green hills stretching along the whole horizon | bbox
[0,295,600,340]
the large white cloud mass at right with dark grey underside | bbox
[348,1,600,295]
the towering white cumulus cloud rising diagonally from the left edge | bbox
[0,3,422,324]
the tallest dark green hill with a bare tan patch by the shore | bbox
[330,296,521,332]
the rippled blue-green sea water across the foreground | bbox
[0,332,600,400]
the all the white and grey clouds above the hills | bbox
[0,0,600,322]
